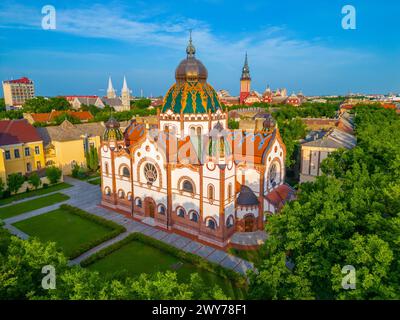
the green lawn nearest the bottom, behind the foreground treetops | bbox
[87,241,244,299]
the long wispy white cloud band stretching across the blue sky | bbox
[0,4,374,95]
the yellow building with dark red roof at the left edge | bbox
[0,119,45,183]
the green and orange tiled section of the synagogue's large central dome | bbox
[162,81,222,113]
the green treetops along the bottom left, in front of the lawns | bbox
[0,228,227,300]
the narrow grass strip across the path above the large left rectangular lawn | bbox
[0,193,69,219]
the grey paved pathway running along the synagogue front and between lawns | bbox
[4,177,254,274]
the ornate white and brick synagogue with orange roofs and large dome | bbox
[100,39,289,247]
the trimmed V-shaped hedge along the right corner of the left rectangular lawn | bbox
[60,204,126,259]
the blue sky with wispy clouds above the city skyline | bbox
[0,0,400,96]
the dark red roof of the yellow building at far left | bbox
[0,119,42,146]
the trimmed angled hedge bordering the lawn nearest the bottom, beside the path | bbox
[81,232,246,286]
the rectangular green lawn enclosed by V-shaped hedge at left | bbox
[14,208,113,257]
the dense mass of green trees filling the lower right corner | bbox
[249,106,400,299]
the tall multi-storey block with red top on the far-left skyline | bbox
[3,77,35,108]
